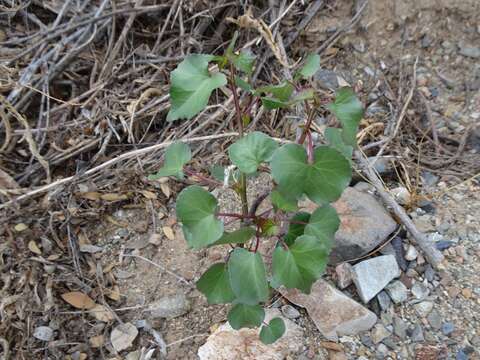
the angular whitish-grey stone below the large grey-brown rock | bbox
[352,255,400,303]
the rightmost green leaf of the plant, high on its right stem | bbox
[328,87,363,147]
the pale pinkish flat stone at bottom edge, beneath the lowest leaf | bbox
[198,309,304,360]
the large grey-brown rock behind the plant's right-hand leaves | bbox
[332,187,397,263]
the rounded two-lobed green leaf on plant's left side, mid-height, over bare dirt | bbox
[176,185,223,249]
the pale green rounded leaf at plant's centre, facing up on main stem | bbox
[228,131,278,174]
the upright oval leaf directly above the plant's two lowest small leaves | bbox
[228,248,268,305]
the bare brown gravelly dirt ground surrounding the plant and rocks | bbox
[0,0,480,360]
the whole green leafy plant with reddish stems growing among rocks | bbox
[150,36,363,344]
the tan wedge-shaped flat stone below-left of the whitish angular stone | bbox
[279,279,377,341]
